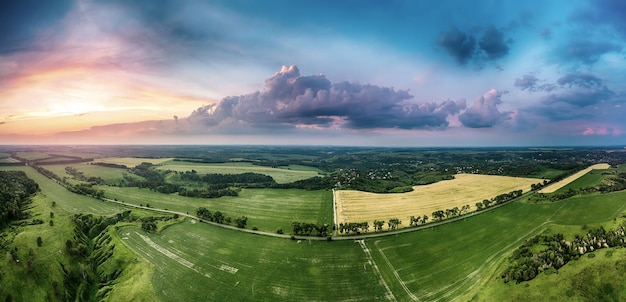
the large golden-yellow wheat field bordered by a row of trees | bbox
[335,174,543,227]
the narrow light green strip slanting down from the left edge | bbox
[0,166,124,215]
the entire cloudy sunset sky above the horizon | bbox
[0,0,626,147]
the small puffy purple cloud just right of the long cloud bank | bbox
[459,89,507,128]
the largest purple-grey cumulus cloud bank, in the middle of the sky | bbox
[186,66,465,129]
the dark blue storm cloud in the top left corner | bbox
[0,0,74,54]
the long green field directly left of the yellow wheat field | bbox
[101,186,333,233]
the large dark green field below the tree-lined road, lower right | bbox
[366,192,626,301]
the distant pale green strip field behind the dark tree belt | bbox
[158,161,322,183]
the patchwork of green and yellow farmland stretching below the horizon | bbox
[0,146,626,301]
